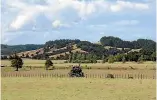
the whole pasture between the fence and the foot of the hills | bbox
[1,59,156,78]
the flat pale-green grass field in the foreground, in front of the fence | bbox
[1,78,156,100]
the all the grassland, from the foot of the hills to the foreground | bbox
[1,59,156,100]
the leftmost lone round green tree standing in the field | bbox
[11,54,23,71]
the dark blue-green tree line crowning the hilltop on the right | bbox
[100,36,156,52]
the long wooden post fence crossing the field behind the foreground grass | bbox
[1,72,156,79]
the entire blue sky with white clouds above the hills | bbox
[1,0,156,45]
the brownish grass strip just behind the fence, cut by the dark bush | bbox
[1,67,156,77]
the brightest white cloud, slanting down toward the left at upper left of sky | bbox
[8,0,46,30]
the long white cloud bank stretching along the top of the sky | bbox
[7,0,149,29]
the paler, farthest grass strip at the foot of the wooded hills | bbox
[1,59,156,69]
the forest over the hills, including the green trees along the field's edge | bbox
[2,36,156,63]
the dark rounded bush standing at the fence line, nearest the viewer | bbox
[69,66,84,77]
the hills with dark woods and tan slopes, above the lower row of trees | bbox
[2,36,156,60]
